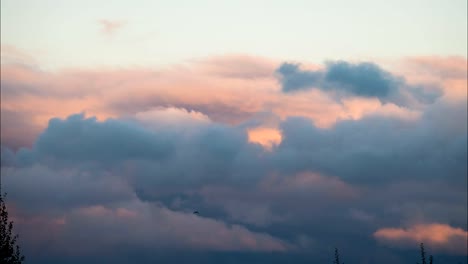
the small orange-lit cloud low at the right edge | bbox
[374,223,468,255]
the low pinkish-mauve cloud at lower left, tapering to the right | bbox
[9,199,295,255]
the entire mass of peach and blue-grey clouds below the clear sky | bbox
[1,50,468,263]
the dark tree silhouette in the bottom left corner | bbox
[0,184,24,264]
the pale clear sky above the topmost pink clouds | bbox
[1,0,467,69]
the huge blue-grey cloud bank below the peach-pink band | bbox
[1,101,466,260]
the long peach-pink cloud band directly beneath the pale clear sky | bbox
[1,49,458,146]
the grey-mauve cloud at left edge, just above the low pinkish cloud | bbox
[1,164,135,214]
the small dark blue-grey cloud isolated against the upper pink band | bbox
[276,61,441,105]
